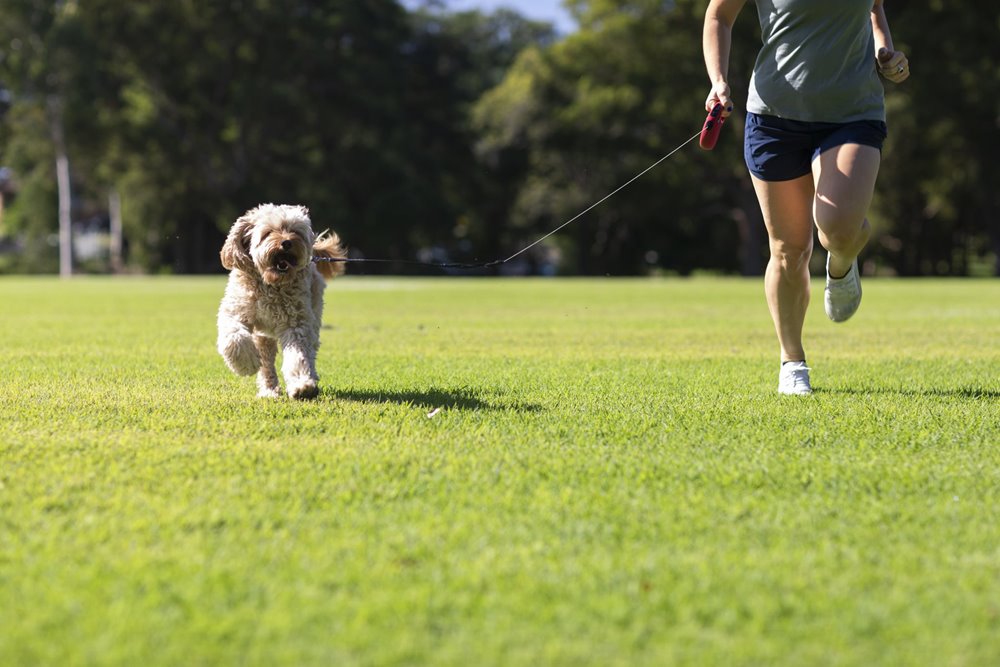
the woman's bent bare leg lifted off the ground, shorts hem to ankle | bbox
[812,144,882,278]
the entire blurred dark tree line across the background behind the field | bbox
[0,0,1000,275]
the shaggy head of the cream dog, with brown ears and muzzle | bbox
[221,204,315,285]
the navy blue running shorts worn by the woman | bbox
[743,112,887,181]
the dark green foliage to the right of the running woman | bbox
[876,0,1000,275]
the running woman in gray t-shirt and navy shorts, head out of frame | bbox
[703,0,910,394]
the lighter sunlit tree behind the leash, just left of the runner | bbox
[476,0,760,274]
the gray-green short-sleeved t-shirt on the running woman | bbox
[747,0,885,123]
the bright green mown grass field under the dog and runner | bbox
[0,277,1000,667]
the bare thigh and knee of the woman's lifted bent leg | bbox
[812,144,882,234]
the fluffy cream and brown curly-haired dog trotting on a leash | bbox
[218,204,344,399]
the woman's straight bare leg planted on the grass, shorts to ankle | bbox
[751,174,814,362]
